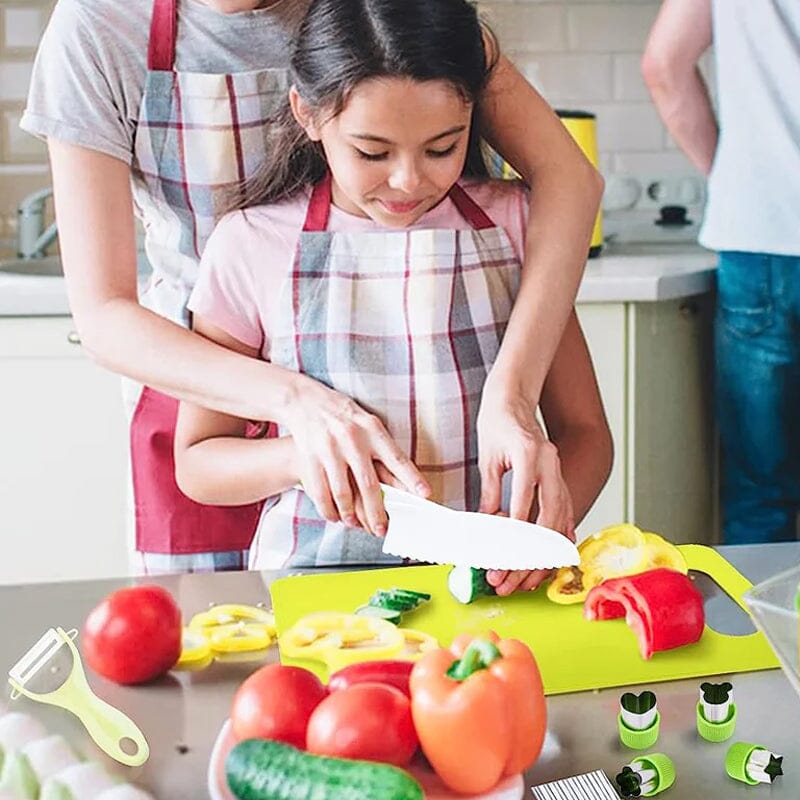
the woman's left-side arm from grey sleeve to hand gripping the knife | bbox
[48,139,429,533]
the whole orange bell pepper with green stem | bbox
[410,632,547,794]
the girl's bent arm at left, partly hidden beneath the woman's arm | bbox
[175,317,300,506]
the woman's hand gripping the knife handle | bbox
[284,375,430,536]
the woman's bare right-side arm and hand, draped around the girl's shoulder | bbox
[478,55,603,524]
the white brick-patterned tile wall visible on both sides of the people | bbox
[0,0,712,245]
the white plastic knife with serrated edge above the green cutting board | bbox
[381,484,580,569]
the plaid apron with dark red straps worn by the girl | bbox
[250,177,520,569]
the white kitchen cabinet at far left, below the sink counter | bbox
[0,317,128,583]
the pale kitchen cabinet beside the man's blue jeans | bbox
[578,293,718,543]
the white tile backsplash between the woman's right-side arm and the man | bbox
[480,0,700,175]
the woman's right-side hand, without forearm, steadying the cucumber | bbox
[478,389,575,541]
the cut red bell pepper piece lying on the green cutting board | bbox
[583,568,705,659]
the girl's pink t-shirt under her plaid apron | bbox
[189,179,528,359]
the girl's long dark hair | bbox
[225,0,497,211]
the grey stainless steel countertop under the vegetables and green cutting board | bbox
[0,543,800,800]
